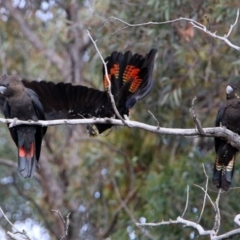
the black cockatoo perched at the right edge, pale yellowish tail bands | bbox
[213,77,240,191]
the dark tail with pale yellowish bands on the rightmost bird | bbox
[213,144,236,191]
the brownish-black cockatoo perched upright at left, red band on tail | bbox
[0,75,47,178]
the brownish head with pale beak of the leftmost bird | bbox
[0,74,24,97]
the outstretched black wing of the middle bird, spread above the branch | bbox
[23,80,108,120]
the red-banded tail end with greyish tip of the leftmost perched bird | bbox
[18,142,37,178]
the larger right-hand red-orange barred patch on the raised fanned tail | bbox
[123,65,142,92]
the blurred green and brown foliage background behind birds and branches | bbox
[0,0,240,240]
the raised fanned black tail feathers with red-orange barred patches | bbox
[103,49,157,101]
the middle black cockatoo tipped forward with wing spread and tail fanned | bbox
[23,49,157,135]
